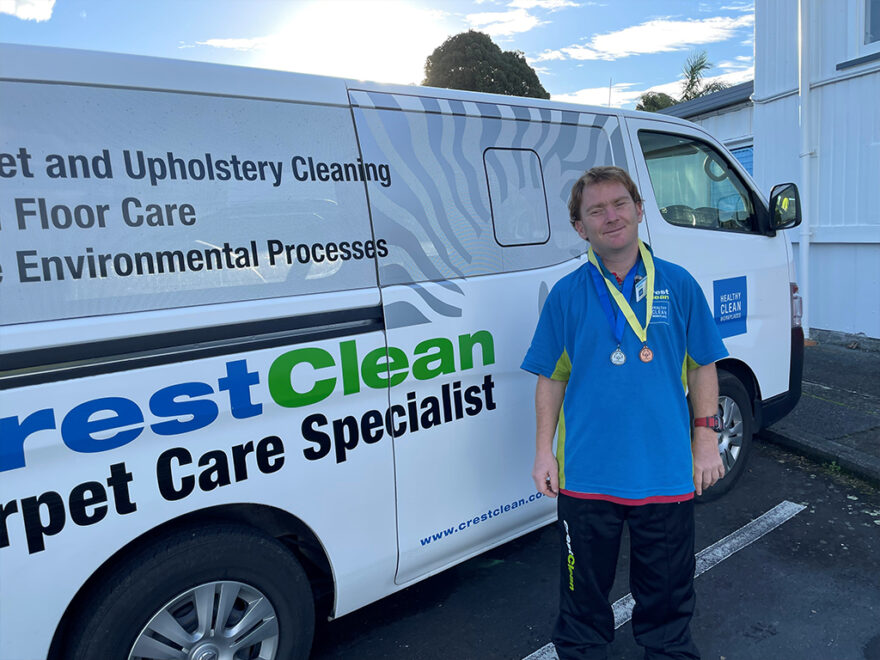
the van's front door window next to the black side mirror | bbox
[639,131,758,233]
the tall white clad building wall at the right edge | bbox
[753,0,880,337]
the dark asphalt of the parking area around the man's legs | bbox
[312,442,880,660]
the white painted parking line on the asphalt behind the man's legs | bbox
[523,500,807,660]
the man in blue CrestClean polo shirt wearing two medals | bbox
[522,167,727,660]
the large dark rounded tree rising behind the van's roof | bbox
[422,30,550,99]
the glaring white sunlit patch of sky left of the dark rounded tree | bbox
[191,0,461,84]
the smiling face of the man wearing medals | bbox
[574,181,642,257]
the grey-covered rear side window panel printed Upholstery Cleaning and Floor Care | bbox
[0,82,382,325]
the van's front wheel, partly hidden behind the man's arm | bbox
[697,370,752,502]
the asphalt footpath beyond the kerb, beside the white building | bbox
[759,342,880,486]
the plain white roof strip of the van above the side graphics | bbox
[0,43,689,129]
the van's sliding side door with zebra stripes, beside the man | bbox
[350,90,623,583]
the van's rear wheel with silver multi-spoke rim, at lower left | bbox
[65,525,315,660]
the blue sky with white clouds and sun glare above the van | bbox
[0,0,754,108]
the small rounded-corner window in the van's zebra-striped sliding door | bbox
[483,149,550,246]
